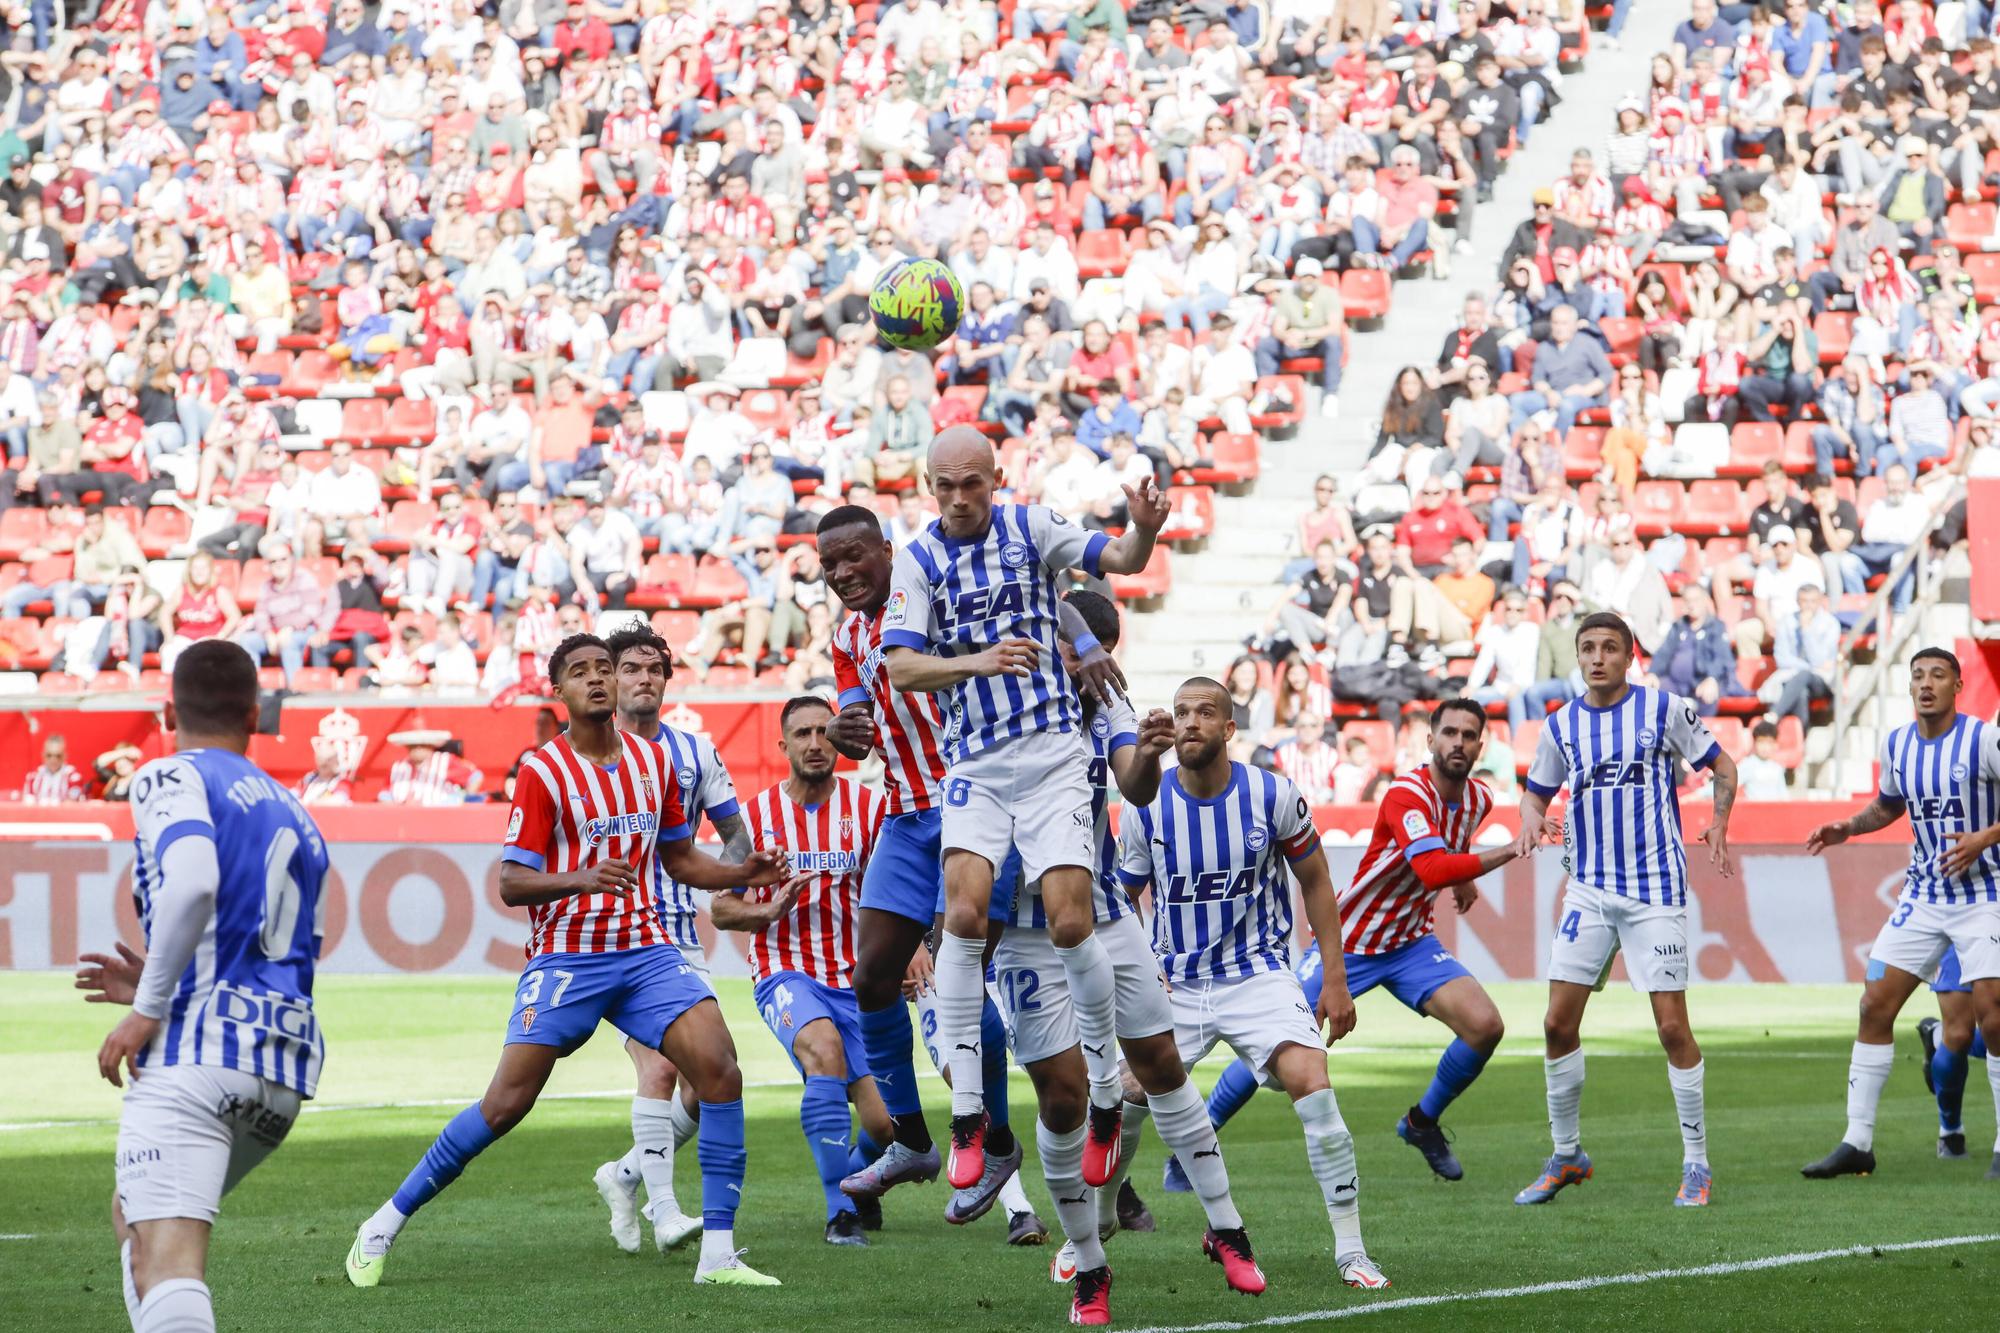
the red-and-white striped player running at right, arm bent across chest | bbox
[1166,699,1516,1189]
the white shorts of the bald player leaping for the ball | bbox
[942,731,1096,885]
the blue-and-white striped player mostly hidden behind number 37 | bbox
[592,620,750,1255]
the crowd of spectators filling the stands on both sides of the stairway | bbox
[0,0,2000,804]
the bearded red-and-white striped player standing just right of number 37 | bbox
[710,695,894,1245]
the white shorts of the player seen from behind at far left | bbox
[118,1065,300,1223]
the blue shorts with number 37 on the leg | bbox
[506,945,714,1055]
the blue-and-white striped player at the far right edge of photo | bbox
[1804,648,2000,1181]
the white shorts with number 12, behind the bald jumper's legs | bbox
[994,915,1174,1065]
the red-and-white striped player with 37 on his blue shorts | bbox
[346,634,798,1287]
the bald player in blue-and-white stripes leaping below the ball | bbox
[882,426,1168,1189]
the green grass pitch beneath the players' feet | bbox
[0,975,2000,1333]
